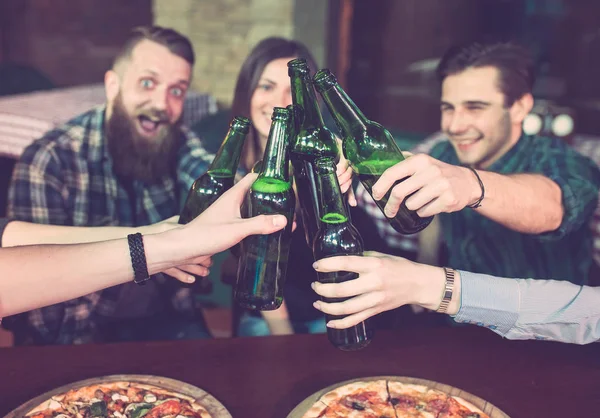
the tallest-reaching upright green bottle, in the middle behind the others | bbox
[288,58,339,247]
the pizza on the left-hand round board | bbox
[25,381,212,418]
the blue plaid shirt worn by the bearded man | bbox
[5,106,212,344]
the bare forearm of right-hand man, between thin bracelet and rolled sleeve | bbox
[475,171,564,234]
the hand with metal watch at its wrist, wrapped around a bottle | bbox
[312,252,460,329]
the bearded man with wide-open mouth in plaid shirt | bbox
[4,27,211,344]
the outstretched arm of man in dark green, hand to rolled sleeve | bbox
[373,148,600,235]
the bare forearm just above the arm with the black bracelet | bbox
[2,221,174,247]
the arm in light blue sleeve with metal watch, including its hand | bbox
[313,253,600,344]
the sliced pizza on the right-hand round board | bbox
[303,379,489,418]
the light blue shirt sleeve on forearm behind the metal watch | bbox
[455,272,600,344]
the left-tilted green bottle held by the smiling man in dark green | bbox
[314,70,433,234]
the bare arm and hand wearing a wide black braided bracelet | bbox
[0,175,286,316]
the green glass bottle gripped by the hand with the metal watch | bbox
[313,158,374,351]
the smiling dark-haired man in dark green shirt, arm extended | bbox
[366,43,600,283]
